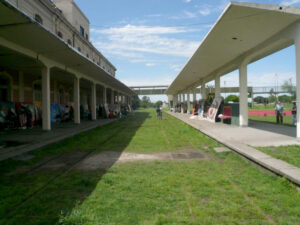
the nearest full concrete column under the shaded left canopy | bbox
[42,67,51,131]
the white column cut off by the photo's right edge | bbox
[294,24,300,140]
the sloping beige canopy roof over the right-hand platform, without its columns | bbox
[166,2,300,94]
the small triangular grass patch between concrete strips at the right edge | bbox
[258,146,300,168]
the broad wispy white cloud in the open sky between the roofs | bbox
[92,25,199,59]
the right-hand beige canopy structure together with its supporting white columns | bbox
[166,2,300,139]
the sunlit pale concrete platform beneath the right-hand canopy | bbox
[167,112,300,186]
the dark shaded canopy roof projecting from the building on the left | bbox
[0,0,135,95]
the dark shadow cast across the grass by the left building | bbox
[0,112,149,225]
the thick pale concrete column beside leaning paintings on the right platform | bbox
[239,63,248,127]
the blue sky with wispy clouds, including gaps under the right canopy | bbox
[75,0,300,101]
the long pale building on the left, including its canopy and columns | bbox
[0,0,134,130]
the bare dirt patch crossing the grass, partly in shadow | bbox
[77,151,208,170]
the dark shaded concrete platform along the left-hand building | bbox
[0,119,115,161]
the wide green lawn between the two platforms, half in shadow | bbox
[0,109,300,225]
